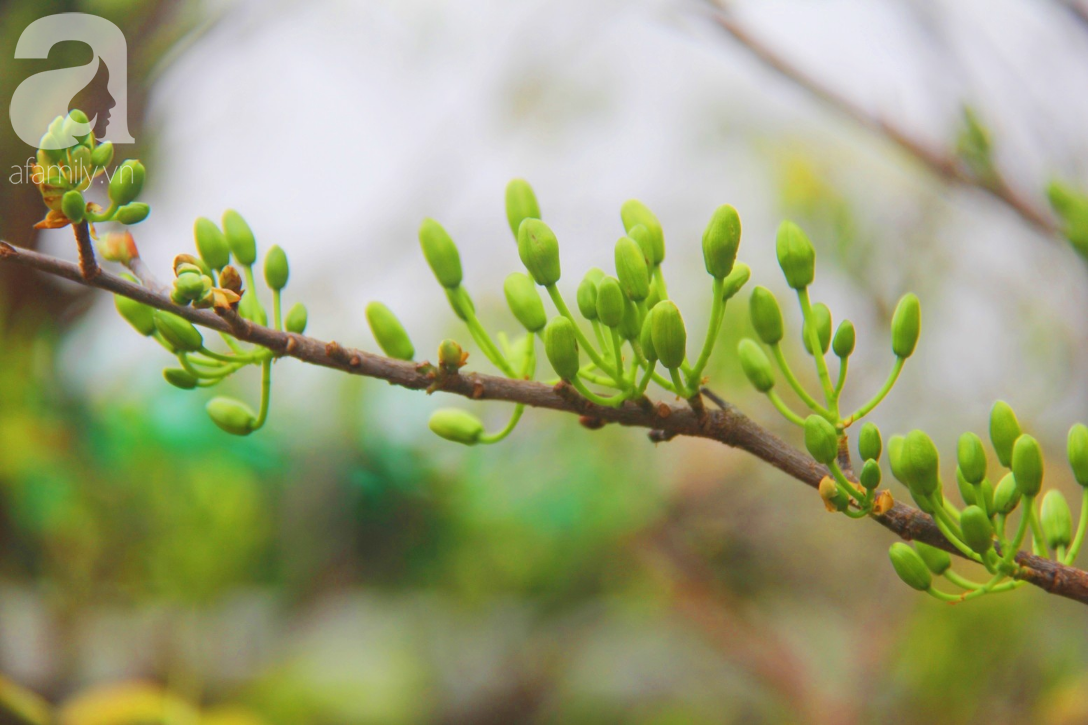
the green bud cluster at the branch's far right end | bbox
[888,401,1088,602]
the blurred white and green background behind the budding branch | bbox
[0,0,1088,725]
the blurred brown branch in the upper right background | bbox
[710,7,1061,236]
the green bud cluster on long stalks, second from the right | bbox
[737,221,922,518]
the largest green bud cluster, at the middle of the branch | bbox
[367,180,751,444]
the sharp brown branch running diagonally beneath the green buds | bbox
[0,242,1088,604]
